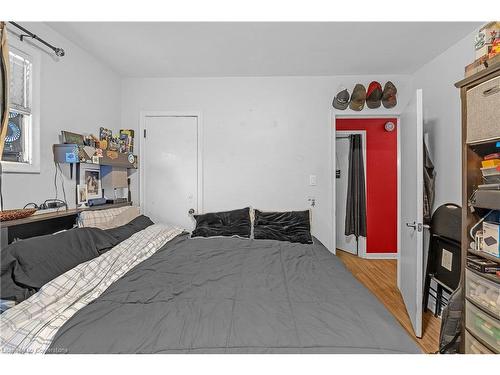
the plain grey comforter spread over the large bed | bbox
[49,235,420,353]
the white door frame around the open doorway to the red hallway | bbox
[330,114,401,276]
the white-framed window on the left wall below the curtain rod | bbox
[2,34,40,173]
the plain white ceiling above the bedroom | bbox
[48,22,480,77]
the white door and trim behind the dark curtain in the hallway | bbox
[335,130,366,257]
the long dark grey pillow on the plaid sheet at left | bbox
[0,216,152,303]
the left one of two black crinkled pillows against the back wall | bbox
[191,207,252,238]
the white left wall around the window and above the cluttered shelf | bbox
[2,23,121,209]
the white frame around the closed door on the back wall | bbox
[138,111,204,213]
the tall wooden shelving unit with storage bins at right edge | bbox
[455,64,500,353]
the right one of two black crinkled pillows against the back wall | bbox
[253,210,312,244]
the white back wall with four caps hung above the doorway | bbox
[122,76,411,249]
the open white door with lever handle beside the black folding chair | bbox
[398,89,424,337]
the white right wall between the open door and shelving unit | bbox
[413,33,476,208]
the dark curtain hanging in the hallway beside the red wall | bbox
[345,134,366,253]
